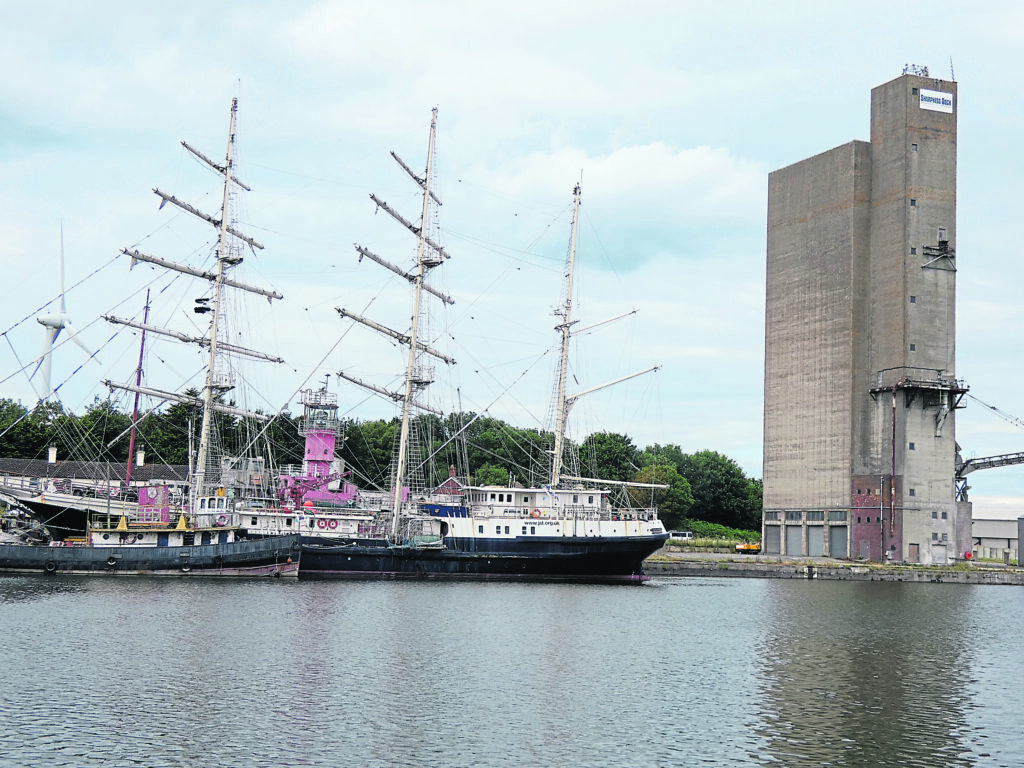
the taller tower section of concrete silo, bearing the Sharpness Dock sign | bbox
[853,75,966,563]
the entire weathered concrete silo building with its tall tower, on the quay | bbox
[763,75,970,563]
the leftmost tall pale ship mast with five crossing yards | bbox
[104,98,284,510]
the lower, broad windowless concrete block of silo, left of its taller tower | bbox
[764,141,870,518]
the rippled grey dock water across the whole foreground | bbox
[0,577,1024,768]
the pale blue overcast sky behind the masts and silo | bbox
[0,0,1024,514]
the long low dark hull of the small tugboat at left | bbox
[0,535,300,577]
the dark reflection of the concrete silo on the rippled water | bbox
[759,582,984,766]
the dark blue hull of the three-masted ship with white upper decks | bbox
[299,535,667,583]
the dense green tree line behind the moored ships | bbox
[0,398,762,529]
